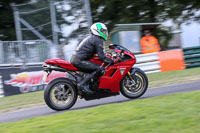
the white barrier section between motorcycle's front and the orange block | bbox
[134,53,161,73]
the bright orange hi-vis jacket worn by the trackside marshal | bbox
[140,36,161,54]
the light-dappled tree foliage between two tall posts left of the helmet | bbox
[57,0,88,44]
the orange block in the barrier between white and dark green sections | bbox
[158,49,185,72]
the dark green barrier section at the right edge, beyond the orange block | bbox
[183,46,200,68]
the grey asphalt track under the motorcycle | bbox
[0,81,200,123]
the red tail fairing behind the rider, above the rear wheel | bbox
[45,58,78,71]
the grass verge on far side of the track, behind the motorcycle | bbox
[0,68,200,113]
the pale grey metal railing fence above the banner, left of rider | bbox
[0,40,52,64]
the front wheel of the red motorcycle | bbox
[120,69,148,99]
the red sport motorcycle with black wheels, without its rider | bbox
[42,45,148,111]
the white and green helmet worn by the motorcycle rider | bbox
[90,23,108,40]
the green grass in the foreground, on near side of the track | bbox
[0,91,200,133]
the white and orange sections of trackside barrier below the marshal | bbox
[134,49,185,73]
